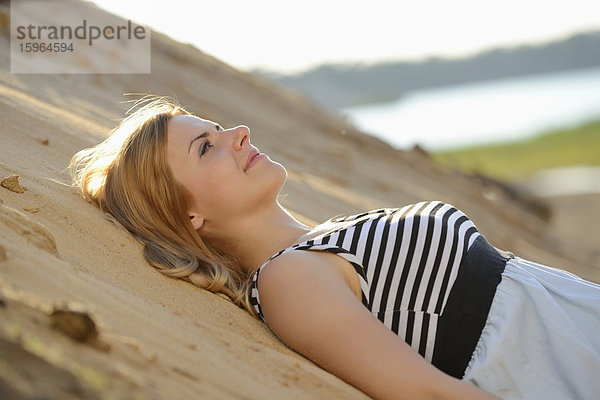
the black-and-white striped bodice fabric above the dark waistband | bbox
[250,201,501,374]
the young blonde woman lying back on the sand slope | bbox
[70,98,600,400]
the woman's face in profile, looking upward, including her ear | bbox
[167,115,287,230]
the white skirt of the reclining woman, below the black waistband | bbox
[463,257,600,400]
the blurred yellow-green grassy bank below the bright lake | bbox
[433,120,600,181]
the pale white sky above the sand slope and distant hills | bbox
[93,0,600,72]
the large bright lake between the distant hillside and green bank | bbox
[342,68,600,151]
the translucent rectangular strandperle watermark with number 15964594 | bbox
[10,0,150,73]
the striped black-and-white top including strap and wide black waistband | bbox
[250,201,512,378]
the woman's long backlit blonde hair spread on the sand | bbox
[67,96,258,318]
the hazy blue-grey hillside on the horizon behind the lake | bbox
[255,31,600,108]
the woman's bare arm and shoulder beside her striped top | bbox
[258,251,497,400]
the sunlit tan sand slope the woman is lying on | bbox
[0,3,600,399]
